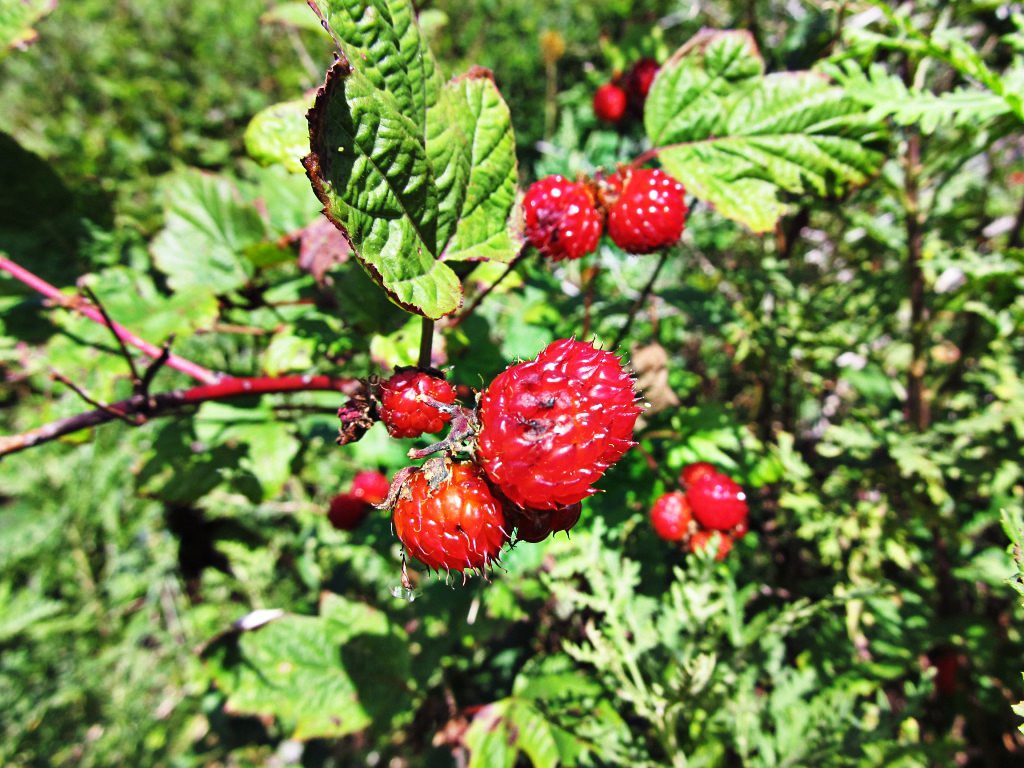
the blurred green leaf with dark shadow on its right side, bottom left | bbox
[206,593,409,739]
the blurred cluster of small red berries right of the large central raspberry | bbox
[650,462,749,560]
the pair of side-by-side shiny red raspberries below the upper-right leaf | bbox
[522,166,687,261]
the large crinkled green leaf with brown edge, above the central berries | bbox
[303,0,517,318]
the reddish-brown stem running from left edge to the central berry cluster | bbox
[0,376,362,457]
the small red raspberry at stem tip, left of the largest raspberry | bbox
[378,369,455,437]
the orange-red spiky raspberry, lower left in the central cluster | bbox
[392,463,509,570]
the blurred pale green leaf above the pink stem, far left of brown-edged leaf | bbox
[151,170,264,294]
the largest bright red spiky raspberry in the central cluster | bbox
[477,339,640,509]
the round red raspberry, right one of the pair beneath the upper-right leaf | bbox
[603,168,688,253]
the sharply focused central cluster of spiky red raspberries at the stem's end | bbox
[339,339,640,570]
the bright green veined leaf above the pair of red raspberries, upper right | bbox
[644,32,883,232]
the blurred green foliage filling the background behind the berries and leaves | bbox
[0,0,1024,766]
